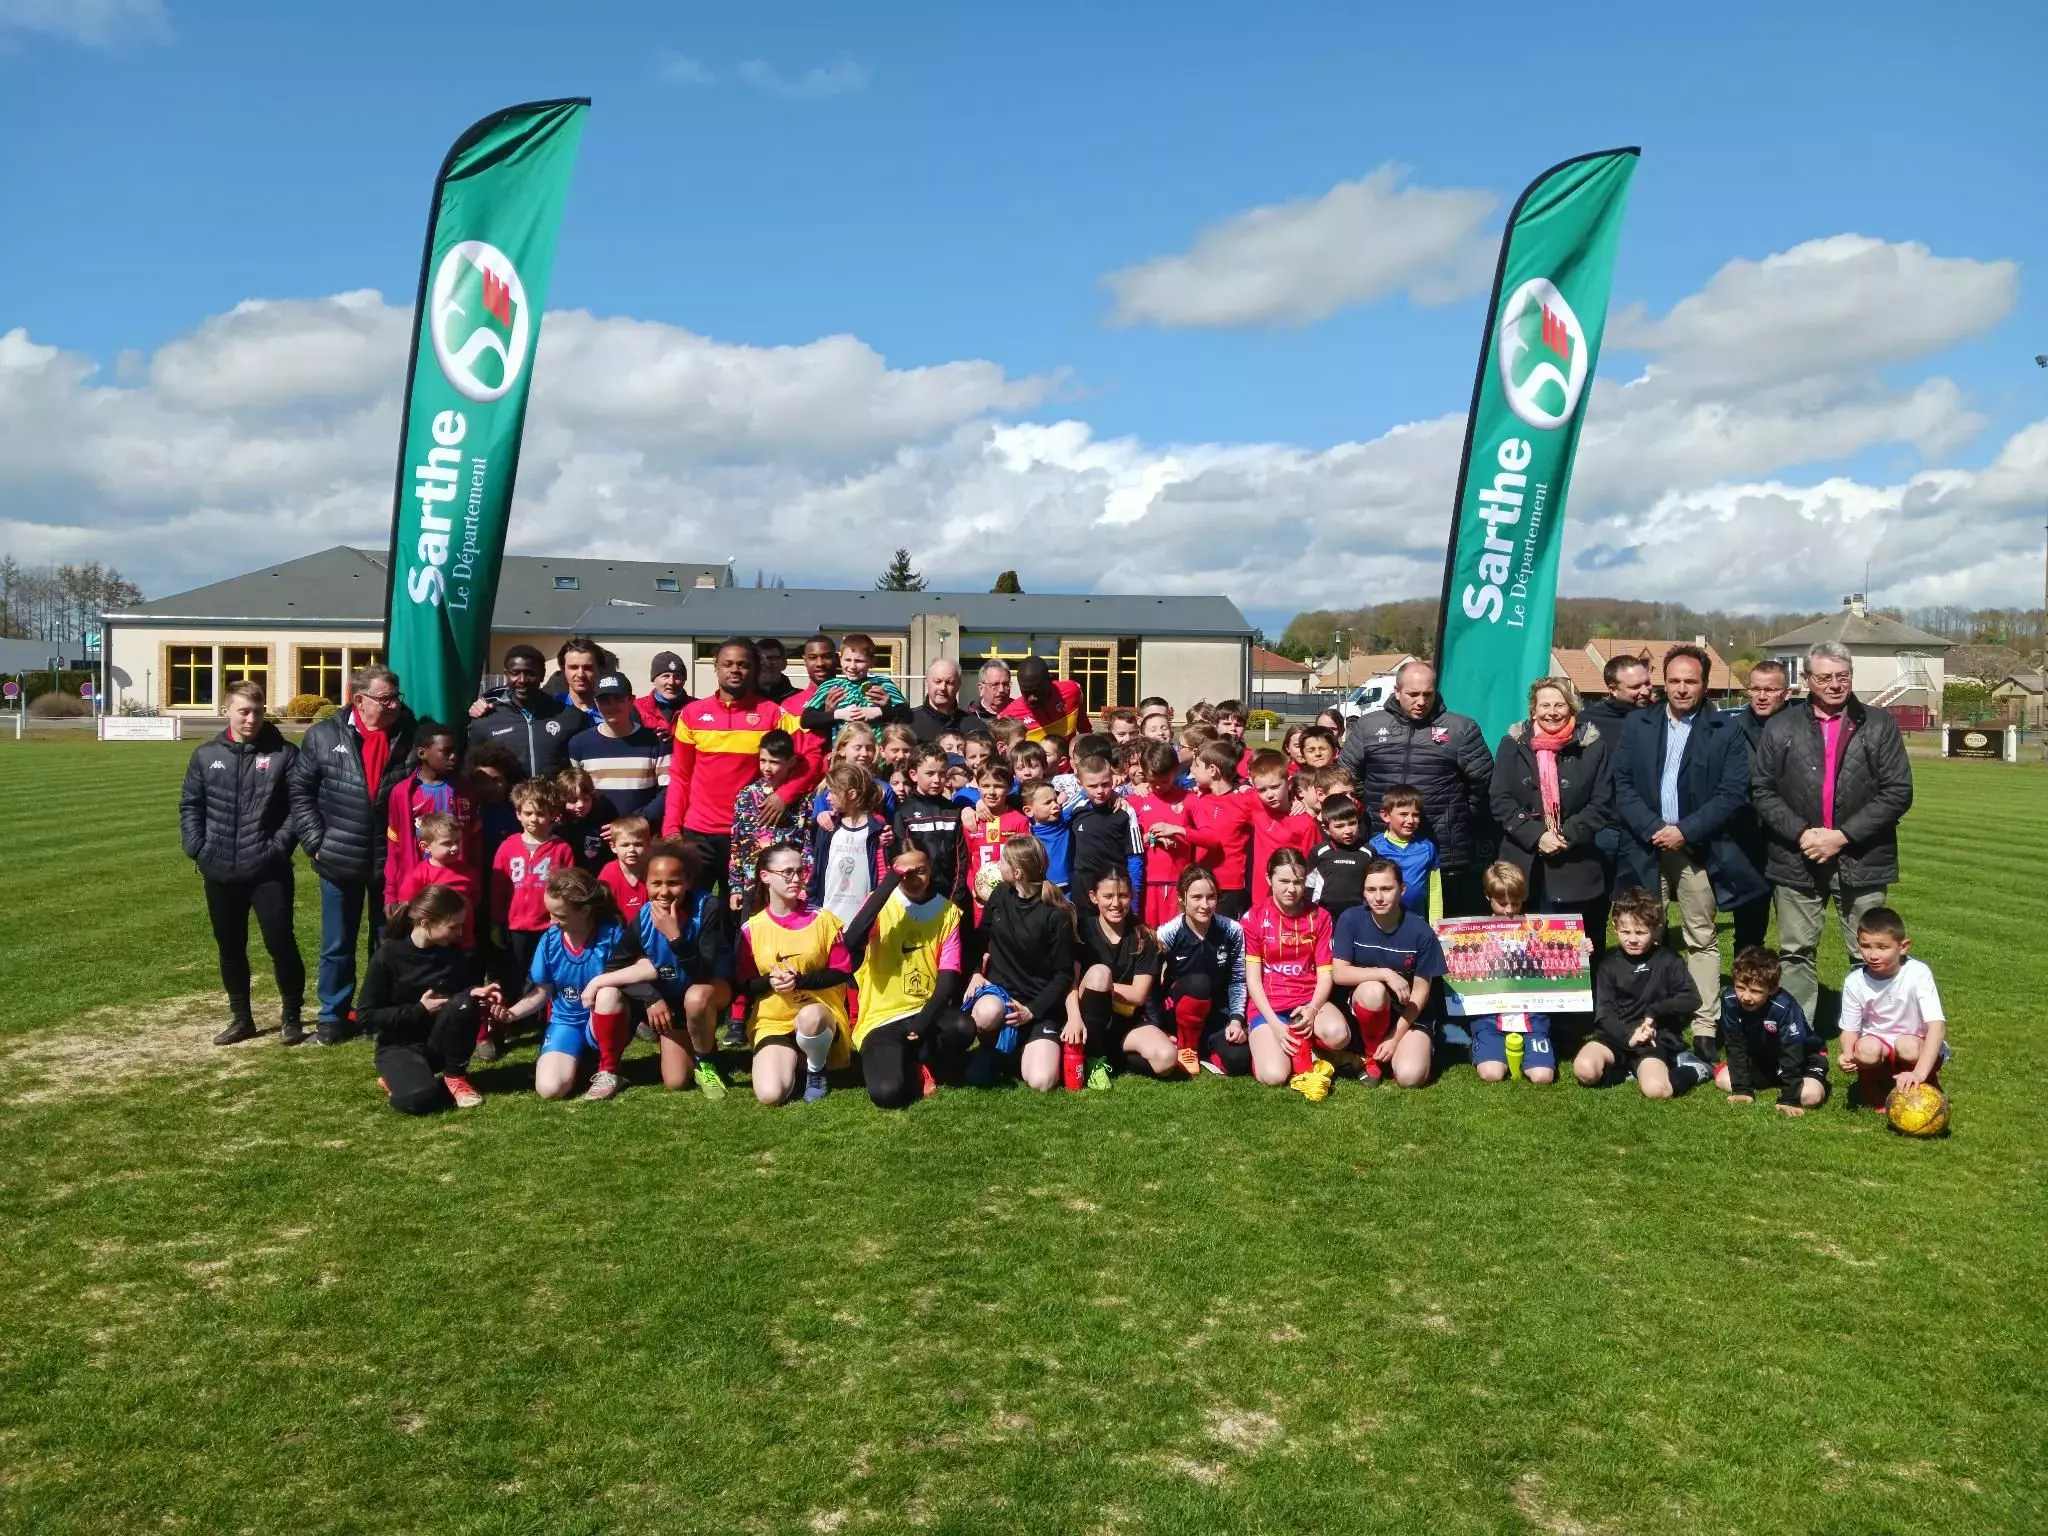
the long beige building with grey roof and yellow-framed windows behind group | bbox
[112,545,1251,715]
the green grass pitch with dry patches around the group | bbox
[0,741,2048,1536]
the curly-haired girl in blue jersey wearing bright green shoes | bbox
[635,842,733,1098]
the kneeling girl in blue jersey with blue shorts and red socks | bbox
[506,868,655,1100]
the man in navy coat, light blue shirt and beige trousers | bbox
[1614,645,1765,1061]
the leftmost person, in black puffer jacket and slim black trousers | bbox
[178,682,305,1044]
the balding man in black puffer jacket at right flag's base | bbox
[1341,662,1495,918]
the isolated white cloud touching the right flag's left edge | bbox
[1102,166,1499,326]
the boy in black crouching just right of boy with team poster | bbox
[1571,887,1708,1098]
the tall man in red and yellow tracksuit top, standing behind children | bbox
[662,639,823,887]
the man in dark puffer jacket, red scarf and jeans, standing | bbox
[291,668,414,1044]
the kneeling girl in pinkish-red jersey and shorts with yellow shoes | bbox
[1245,848,1352,1102]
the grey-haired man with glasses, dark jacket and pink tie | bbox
[1751,641,1913,1018]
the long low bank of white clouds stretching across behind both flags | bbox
[0,231,2048,610]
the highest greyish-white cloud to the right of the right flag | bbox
[1608,236,2019,389]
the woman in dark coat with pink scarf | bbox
[1491,678,1614,958]
